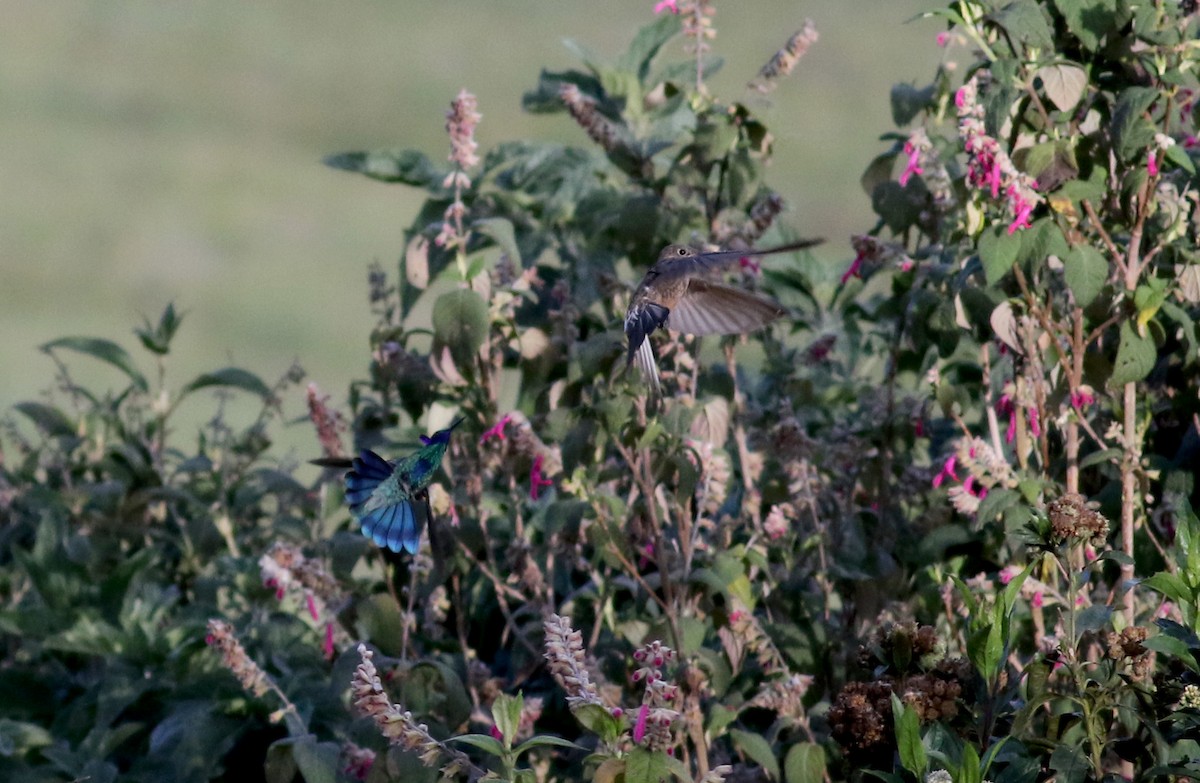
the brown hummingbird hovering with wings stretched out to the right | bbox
[625,239,824,392]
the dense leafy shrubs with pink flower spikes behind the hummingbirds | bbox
[0,0,1200,783]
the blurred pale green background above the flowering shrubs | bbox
[0,0,942,447]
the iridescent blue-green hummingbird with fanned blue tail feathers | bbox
[313,418,463,555]
